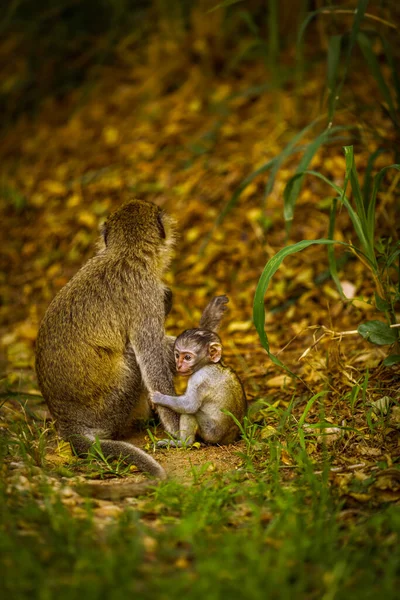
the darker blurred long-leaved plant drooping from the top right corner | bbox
[202,0,400,239]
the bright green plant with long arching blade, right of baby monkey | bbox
[253,146,400,370]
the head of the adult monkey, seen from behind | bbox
[101,200,175,270]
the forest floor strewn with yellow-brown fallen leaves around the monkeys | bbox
[0,19,400,599]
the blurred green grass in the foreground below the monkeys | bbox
[0,410,400,600]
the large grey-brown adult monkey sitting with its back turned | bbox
[36,200,179,478]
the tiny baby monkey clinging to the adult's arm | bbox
[151,296,247,447]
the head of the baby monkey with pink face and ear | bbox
[174,329,222,377]
